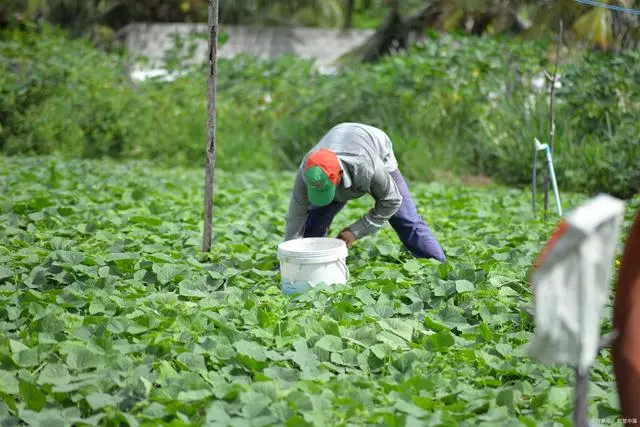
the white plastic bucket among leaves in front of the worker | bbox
[278,237,349,294]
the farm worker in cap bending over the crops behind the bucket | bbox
[285,123,445,262]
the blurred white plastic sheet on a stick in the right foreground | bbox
[529,195,624,373]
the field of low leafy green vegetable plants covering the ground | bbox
[0,157,638,427]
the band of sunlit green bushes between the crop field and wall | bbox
[0,30,640,197]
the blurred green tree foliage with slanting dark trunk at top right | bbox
[347,0,640,62]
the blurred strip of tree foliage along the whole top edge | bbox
[0,0,640,53]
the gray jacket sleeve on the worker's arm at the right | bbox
[349,162,402,239]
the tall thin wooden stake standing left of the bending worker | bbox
[202,0,218,252]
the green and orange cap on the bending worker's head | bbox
[304,148,342,206]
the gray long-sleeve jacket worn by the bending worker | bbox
[285,123,402,240]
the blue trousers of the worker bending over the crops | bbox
[304,169,446,262]
